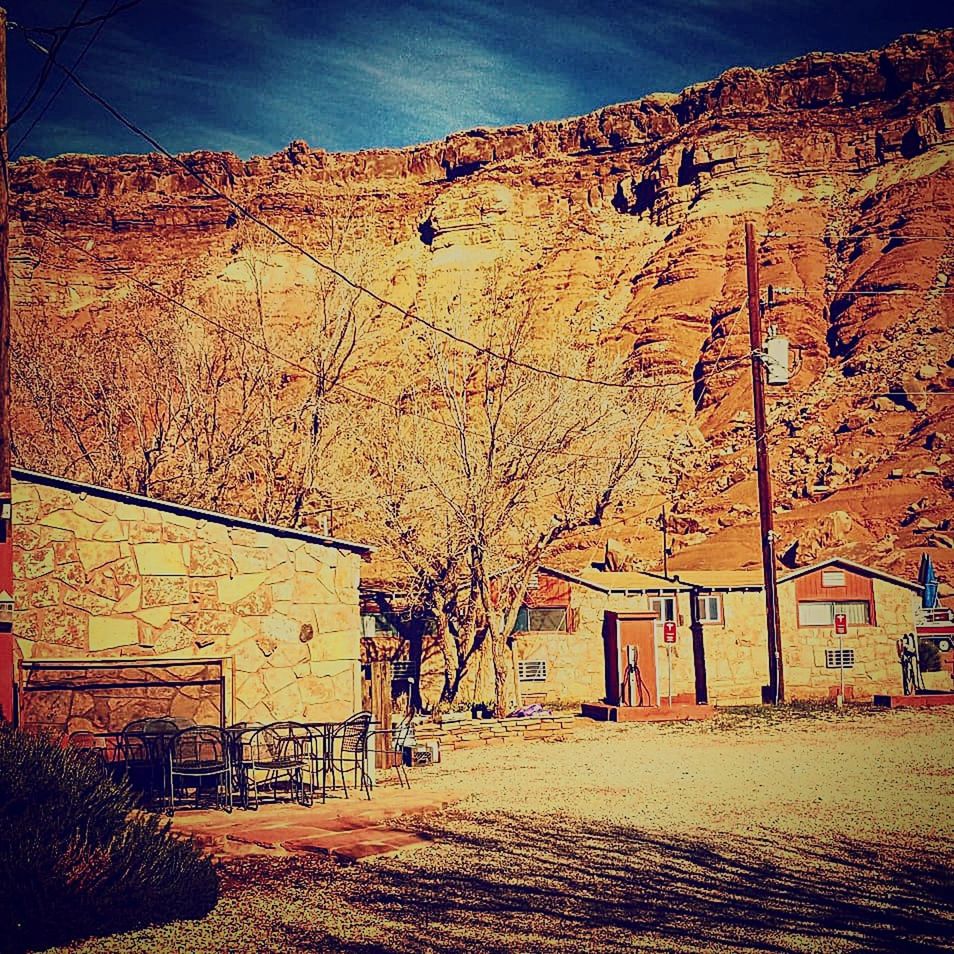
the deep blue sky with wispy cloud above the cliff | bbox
[6,0,954,157]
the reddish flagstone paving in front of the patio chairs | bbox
[172,789,462,864]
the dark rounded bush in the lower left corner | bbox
[0,726,218,952]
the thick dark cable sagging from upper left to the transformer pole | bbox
[20,28,728,390]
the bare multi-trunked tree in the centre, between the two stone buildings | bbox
[354,279,663,712]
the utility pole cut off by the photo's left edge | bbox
[0,7,14,722]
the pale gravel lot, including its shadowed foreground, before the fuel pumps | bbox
[55,708,954,954]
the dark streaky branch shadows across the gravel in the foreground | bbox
[232,813,954,952]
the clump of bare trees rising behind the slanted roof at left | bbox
[12,215,375,526]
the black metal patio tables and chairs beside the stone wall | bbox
[68,712,410,815]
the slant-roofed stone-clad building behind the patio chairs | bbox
[9,470,371,731]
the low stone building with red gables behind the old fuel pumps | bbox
[365,559,921,705]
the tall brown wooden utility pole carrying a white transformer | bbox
[745,222,785,705]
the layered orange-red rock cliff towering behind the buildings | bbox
[11,31,954,573]
